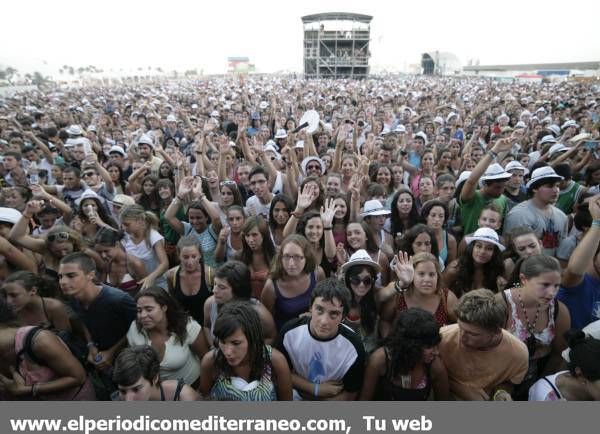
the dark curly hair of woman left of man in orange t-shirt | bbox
[383,307,441,378]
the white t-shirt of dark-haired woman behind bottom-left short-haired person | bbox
[127,318,202,384]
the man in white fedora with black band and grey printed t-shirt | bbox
[504,166,569,256]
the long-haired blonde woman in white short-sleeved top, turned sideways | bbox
[121,205,169,289]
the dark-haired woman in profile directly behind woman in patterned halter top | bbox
[203,261,276,346]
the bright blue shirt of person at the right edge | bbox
[557,273,600,329]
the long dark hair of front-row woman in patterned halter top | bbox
[213,301,266,381]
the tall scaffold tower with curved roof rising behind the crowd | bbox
[302,12,373,79]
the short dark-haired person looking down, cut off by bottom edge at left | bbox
[112,345,199,401]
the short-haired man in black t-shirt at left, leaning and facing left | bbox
[58,252,137,378]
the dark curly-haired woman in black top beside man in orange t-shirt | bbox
[360,308,450,401]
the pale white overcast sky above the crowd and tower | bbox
[0,0,600,73]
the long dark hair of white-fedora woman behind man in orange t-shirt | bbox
[451,241,504,298]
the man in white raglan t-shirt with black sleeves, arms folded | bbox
[275,278,366,401]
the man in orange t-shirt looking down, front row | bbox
[440,289,529,401]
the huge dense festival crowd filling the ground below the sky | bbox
[0,76,600,401]
